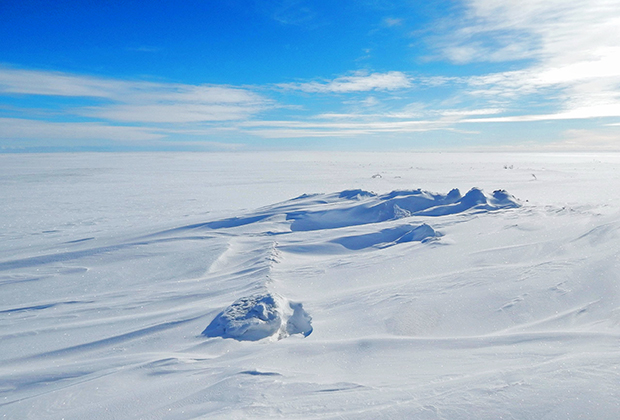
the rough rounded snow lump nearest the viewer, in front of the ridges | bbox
[202,293,312,341]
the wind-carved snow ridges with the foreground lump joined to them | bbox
[199,188,520,341]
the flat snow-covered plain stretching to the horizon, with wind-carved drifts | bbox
[0,152,620,420]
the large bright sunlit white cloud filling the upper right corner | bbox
[428,0,620,122]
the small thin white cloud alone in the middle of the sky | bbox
[277,71,412,93]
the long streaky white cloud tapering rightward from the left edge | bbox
[0,67,270,123]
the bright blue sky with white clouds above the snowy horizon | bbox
[0,0,620,152]
